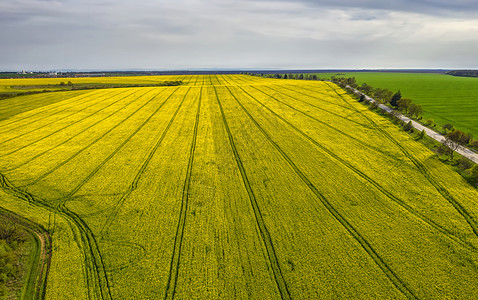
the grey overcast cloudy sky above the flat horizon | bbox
[0,0,478,71]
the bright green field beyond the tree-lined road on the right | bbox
[317,72,478,138]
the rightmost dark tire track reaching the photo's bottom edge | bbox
[222,87,417,299]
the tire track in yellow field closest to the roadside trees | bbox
[327,83,478,237]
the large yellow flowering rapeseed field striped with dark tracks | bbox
[0,75,478,299]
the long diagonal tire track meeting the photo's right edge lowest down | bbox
[233,87,477,251]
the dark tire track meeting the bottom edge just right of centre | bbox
[213,86,291,299]
